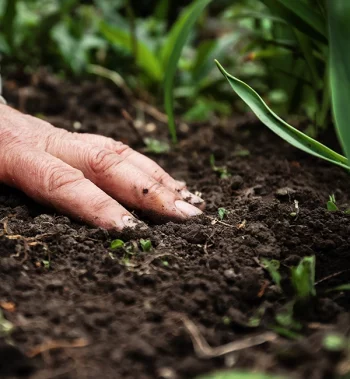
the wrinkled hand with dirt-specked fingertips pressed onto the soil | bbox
[0,104,204,230]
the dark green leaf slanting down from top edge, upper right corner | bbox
[261,0,327,43]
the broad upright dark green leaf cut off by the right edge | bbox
[328,0,350,165]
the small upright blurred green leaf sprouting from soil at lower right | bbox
[291,256,316,299]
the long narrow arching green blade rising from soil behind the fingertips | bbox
[163,0,211,143]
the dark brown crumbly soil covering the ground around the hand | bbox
[0,72,350,379]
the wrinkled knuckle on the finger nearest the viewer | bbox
[43,166,85,192]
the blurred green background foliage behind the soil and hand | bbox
[0,0,328,129]
